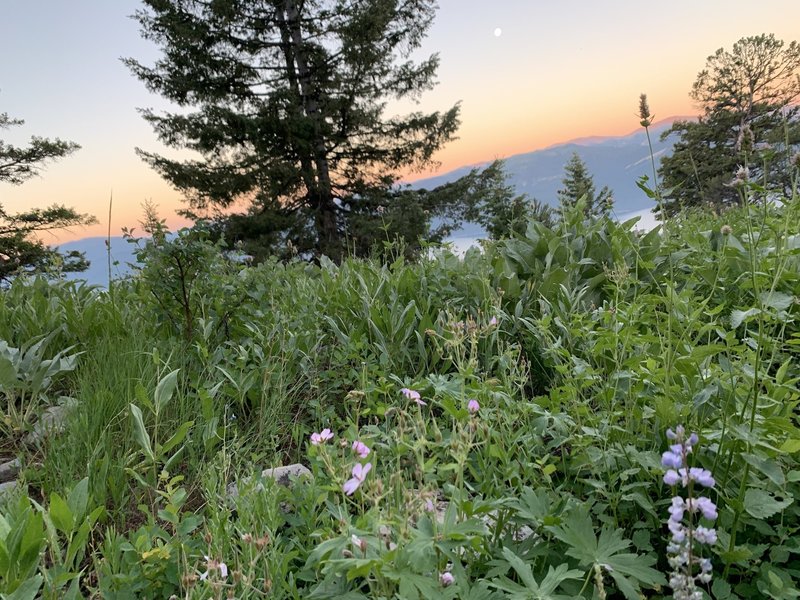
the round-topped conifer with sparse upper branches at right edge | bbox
[660,34,800,214]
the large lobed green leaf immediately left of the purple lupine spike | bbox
[547,508,666,600]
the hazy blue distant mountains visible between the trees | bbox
[60,117,680,285]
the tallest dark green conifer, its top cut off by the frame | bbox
[125,0,459,259]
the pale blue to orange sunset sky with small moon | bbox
[0,0,800,241]
